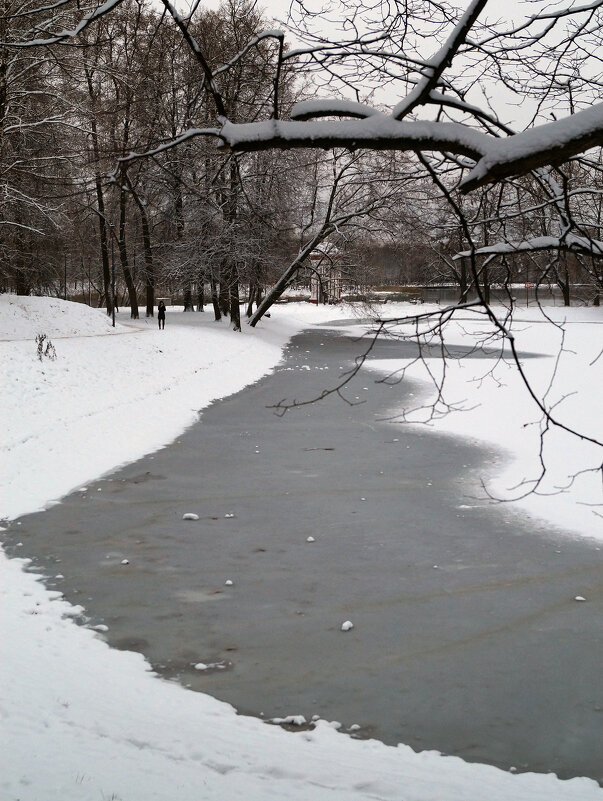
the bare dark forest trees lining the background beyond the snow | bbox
[0,0,603,320]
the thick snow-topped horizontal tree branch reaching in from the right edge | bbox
[115,100,603,198]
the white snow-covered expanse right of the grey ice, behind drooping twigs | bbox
[360,306,603,539]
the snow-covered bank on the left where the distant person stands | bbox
[0,295,340,519]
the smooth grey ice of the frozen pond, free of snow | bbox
[5,320,603,780]
